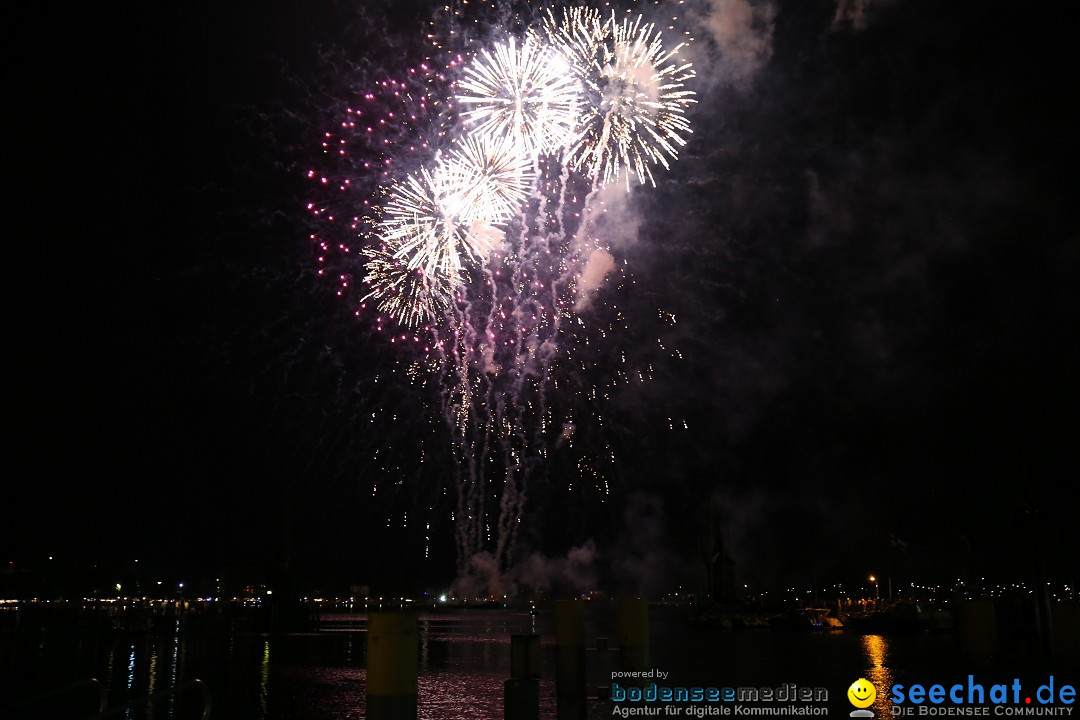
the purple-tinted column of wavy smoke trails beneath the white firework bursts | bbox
[438,162,593,568]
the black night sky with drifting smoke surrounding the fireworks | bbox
[6,0,1080,592]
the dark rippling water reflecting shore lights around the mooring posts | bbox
[0,602,1078,720]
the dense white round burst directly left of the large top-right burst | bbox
[457,32,581,155]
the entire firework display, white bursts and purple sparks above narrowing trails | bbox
[309,3,693,592]
